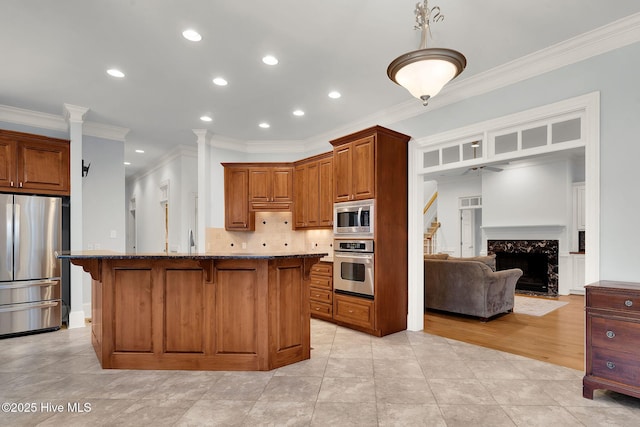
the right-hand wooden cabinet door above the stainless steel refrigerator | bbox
[17,140,71,194]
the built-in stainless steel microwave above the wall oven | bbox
[333,199,375,239]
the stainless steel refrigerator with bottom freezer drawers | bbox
[0,194,62,338]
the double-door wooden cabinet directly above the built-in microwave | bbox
[331,135,376,202]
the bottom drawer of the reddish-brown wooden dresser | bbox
[591,347,640,384]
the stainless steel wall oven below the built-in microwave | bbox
[333,240,374,298]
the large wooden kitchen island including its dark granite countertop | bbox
[58,252,327,371]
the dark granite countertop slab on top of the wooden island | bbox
[56,251,329,260]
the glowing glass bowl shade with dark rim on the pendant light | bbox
[387,49,467,105]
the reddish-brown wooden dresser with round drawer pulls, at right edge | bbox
[582,281,640,399]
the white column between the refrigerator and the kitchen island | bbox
[64,104,89,329]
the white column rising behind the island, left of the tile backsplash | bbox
[193,129,213,253]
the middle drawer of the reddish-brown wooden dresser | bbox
[589,316,640,351]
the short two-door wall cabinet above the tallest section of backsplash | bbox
[249,165,293,211]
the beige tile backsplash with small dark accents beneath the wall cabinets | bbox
[206,212,333,257]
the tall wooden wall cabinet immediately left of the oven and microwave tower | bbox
[294,152,333,229]
